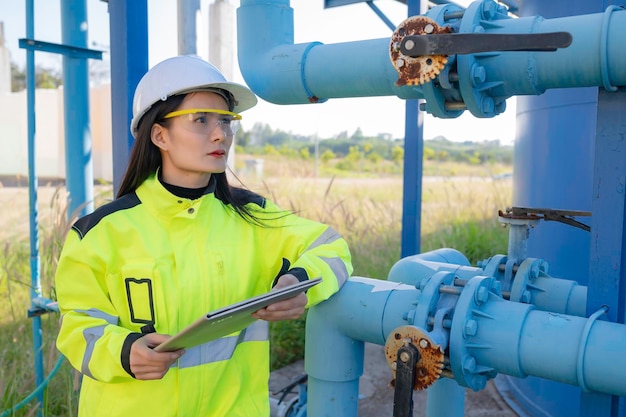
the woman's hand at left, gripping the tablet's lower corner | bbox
[130,333,185,380]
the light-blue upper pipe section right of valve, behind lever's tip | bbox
[470,10,626,97]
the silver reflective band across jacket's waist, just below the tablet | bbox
[178,320,269,369]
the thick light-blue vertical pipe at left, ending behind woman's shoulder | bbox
[61,0,93,216]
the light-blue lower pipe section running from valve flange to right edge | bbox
[466,299,626,396]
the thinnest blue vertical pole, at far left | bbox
[26,0,43,416]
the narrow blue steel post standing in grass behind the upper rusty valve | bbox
[400,0,424,258]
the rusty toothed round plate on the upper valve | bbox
[389,16,450,86]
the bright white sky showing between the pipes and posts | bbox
[0,0,515,144]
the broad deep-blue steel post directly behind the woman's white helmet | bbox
[109,0,148,193]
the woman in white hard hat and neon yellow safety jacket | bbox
[56,56,352,417]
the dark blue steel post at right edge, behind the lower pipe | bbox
[580,84,626,416]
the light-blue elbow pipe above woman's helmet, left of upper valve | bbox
[237,0,422,104]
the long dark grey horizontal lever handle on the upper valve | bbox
[400,32,572,57]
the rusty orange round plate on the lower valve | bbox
[385,326,444,390]
